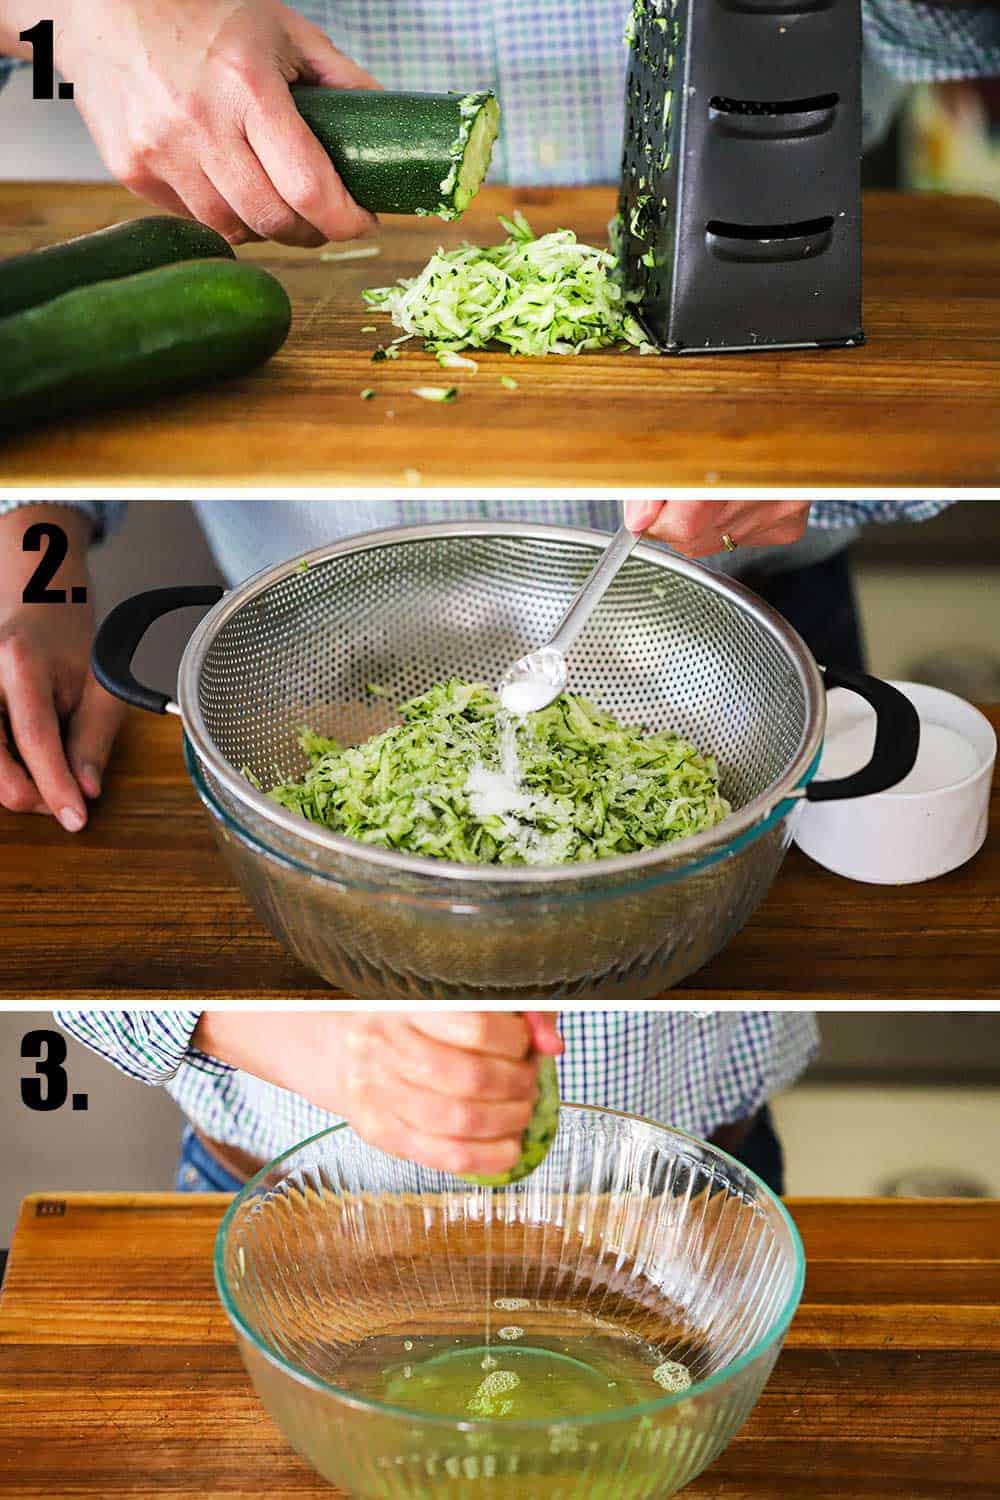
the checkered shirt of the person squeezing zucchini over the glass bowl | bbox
[55,1007,817,1160]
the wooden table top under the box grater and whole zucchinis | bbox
[0,183,1000,495]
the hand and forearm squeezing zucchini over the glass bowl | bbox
[193,1010,562,1176]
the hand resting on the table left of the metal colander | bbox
[0,506,124,833]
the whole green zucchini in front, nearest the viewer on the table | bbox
[0,261,291,429]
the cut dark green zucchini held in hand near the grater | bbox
[292,86,499,219]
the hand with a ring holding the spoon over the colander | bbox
[625,500,810,558]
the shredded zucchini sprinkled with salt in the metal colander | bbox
[268,678,730,864]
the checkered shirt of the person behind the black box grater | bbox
[0,0,1000,153]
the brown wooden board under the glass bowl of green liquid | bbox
[0,1194,1000,1500]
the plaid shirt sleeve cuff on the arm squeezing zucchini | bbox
[54,1011,235,1085]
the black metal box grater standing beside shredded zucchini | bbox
[619,0,864,354]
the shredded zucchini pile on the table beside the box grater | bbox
[364,213,655,354]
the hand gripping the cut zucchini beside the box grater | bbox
[55,0,378,246]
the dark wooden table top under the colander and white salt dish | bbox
[0,705,1000,1002]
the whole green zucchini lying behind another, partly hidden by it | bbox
[0,216,235,318]
